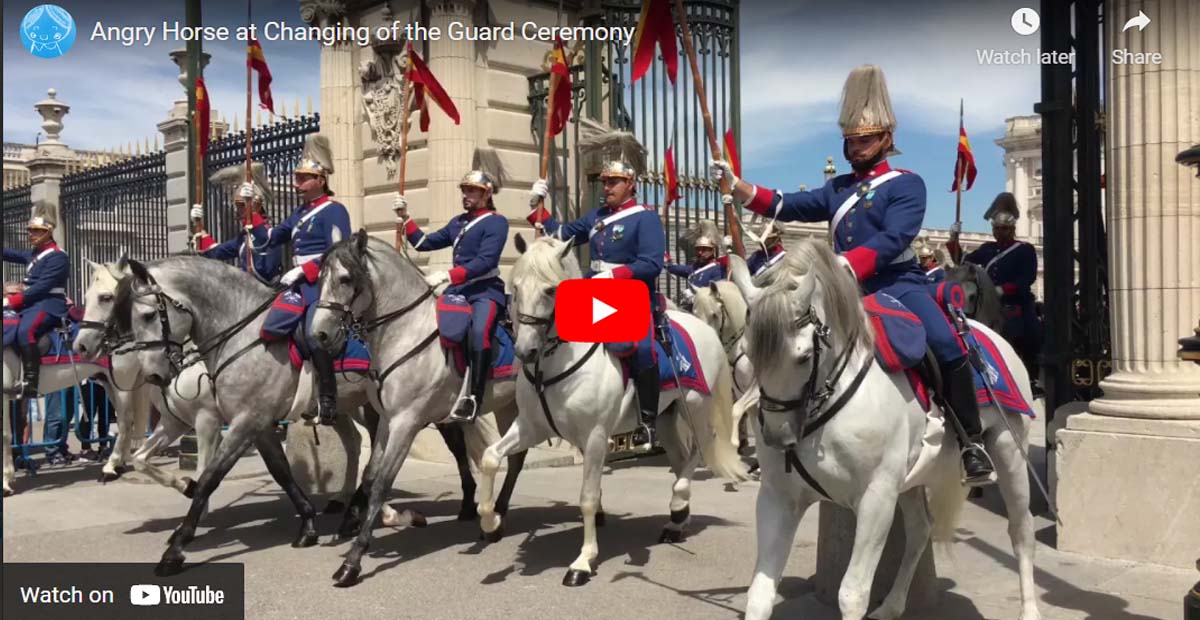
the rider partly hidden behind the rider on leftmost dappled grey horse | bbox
[190,162,283,284]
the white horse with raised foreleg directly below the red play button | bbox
[479,235,745,586]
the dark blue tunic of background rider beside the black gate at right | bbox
[962,241,1038,354]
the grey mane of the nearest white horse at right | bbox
[746,239,875,368]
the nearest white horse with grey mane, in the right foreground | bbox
[731,241,1040,620]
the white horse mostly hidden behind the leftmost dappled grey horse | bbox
[74,257,401,524]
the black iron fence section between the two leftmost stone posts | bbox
[59,151,167,303]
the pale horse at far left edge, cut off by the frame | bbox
[0,326,150,496]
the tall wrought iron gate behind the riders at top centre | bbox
[529,0,740,301]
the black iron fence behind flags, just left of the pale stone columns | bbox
[204,114,320,268]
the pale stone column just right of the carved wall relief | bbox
[422,0,478,270]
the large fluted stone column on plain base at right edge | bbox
[1056,0,1200,566]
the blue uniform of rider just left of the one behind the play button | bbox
[404,209,509,350]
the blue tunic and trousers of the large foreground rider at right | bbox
[748,161,966,363]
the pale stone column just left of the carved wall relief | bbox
[302,2,364,224]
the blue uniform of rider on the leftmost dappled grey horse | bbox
[254,195,350,347]
